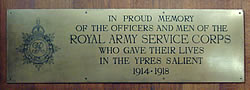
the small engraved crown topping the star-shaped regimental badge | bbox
[32,19,45,36]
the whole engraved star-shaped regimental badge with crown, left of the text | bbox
[16,19,59,71]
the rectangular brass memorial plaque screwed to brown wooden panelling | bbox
[7,9,244,83]
